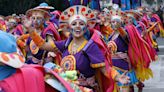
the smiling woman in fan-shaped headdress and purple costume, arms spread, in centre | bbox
[25,5,128,92]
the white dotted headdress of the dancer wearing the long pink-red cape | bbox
[109,5,128,22]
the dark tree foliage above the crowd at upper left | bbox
[0,0,68,16]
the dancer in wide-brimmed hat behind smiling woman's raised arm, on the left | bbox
[17,8,60,63]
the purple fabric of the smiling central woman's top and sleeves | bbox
[55,37,105,78]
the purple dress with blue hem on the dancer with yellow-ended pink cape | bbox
[109,31,138,86]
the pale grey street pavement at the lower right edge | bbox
[135,38,164,92]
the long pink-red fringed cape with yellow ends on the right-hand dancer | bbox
[126,25,154,81]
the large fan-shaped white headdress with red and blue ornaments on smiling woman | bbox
[59,5,96,29]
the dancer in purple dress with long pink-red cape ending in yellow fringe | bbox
[108,5,154,92]
